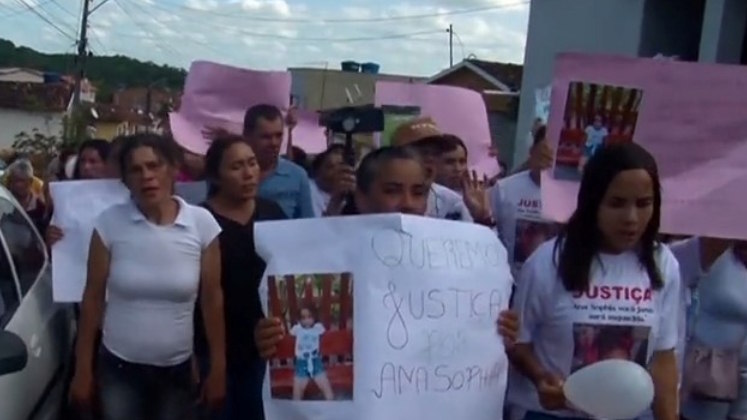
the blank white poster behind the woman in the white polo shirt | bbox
[49,179,207,303]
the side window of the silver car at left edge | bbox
[0,197,46,296]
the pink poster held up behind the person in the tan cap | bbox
[374,82,499,176]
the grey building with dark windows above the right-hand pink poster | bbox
[513,0,747,166]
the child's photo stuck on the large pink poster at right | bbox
[554,82,643,181]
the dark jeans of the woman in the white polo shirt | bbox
[98,346,195,420]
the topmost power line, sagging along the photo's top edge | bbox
[146,0,529,23]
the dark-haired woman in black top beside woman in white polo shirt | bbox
[197,135,286,420]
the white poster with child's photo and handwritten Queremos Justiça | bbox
[255,215,512,420]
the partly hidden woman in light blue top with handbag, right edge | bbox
[672,238,747,420]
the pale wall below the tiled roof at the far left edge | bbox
[0,108,63,149]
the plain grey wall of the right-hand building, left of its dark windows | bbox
[507,0,648,171]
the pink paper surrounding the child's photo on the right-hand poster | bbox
[542,54,747,239]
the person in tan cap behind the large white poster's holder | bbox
[391,117,489,222]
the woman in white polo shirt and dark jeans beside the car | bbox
[71,134,226,420]
